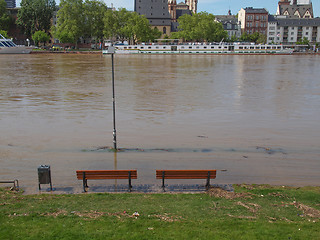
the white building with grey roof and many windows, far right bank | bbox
[267,16,320,45]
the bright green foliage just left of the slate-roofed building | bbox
[103,8,161,43]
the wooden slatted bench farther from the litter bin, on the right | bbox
[156,170,217,191]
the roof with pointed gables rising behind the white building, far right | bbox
[277,0,313,18]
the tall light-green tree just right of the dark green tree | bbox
[52,0,85,48]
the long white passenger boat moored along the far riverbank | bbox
[102,43,293,54]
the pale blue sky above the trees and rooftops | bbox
[16,0,320,17]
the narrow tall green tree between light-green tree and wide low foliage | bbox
[83,0,107,43]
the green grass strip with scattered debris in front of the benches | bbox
[0,185,320,239]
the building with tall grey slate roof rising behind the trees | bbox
[134,0,171,35]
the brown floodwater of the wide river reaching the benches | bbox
[0,54,320,193]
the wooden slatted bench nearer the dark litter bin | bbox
[77,170,137,192]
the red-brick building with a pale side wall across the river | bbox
[238,7,269,35]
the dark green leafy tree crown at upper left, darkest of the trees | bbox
[17,0,56,37]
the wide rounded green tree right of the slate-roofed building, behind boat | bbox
[173,12,228,42]
